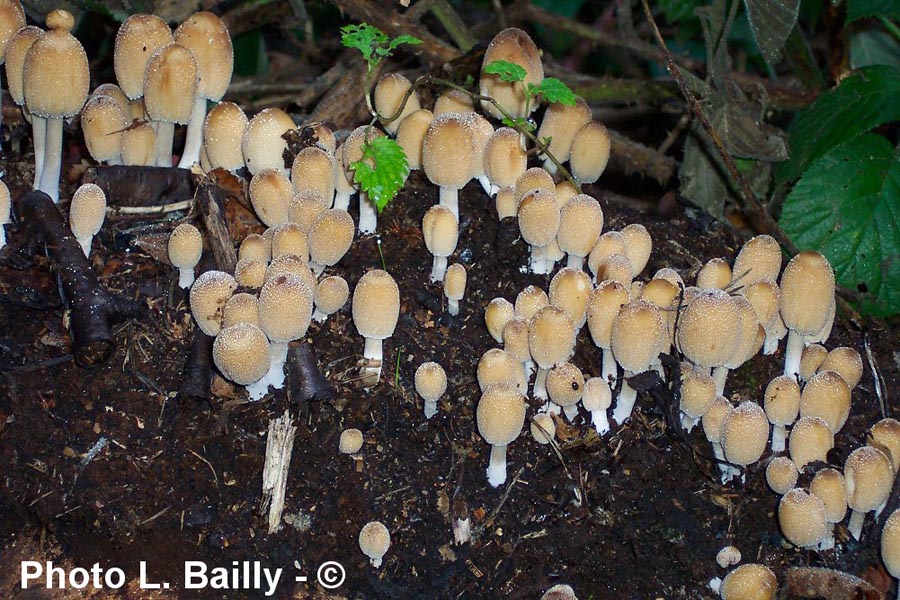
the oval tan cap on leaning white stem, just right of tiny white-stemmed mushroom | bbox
[610,300,666,373]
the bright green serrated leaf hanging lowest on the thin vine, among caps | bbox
[350,136,409,213]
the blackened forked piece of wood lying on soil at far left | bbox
[16,191,143,367]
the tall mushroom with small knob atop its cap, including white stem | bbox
[22,9,90,203]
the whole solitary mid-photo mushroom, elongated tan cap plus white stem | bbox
[353,269,400,388]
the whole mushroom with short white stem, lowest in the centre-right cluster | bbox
[475,383,525,487]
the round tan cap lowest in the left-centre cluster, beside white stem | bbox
[213,323,269,385]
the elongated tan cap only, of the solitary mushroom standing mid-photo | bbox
[353,269,400,340]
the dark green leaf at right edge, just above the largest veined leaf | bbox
[776,65,900,184]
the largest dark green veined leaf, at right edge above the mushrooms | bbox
[779,133,900,316]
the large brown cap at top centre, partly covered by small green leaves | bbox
[479,27,544,119]
